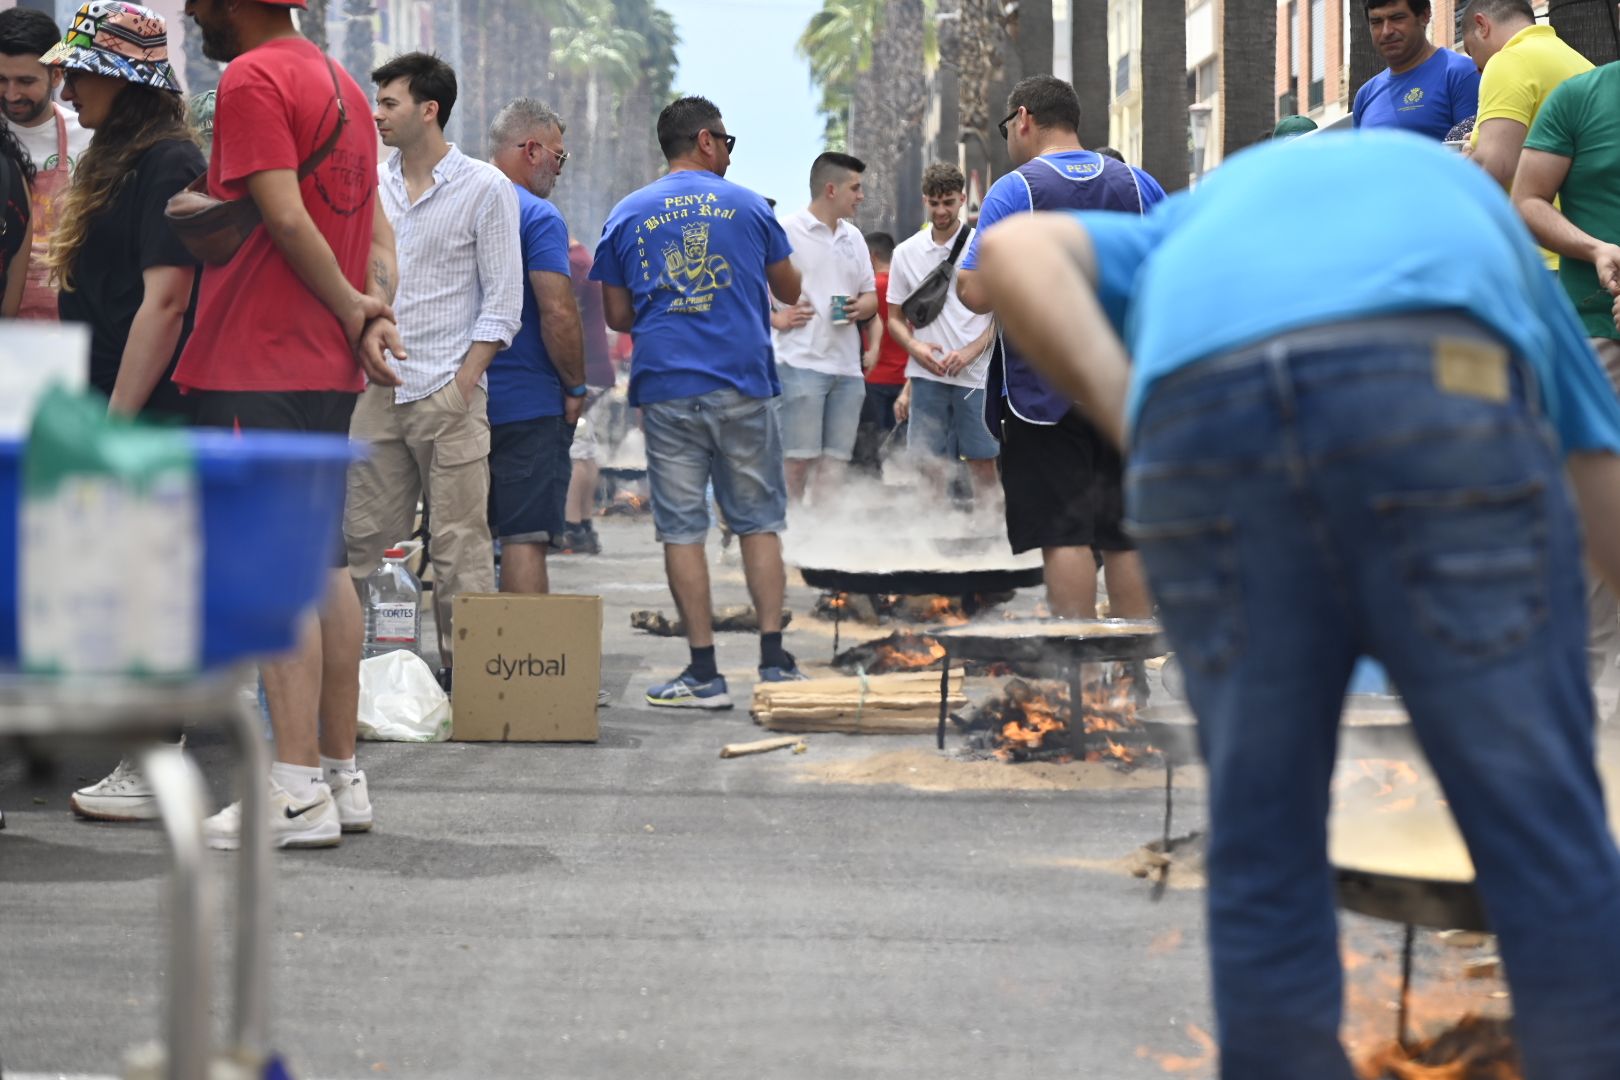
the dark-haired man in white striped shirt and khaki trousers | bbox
[343,52,523,680]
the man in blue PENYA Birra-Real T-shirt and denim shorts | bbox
[591,97,804,709]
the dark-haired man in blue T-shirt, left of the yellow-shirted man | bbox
[1351,0,1479,139]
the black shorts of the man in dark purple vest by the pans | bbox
[1000,410,1136,552]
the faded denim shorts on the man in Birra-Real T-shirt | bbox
[642,389,787,544]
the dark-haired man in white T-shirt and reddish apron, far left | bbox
[0,8,91,322]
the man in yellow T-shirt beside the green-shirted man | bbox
[1463,0,1592,198]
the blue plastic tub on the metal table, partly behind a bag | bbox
[0,429,363,667]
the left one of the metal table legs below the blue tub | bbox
[141,746,214,1080]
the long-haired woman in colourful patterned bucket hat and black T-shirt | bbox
[41,0,207,418]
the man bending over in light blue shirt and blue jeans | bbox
[980,133,1620,1080]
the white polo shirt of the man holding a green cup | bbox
[771,209,878,379]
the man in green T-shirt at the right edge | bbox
[1513,63,1620,702]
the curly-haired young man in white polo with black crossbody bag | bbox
[888,162,1001,510]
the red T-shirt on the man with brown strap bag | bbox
[175,37,377,393]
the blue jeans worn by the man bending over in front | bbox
[1128,316,1620,1080]
